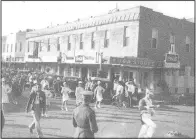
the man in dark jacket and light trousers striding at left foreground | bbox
[26,84,46,137]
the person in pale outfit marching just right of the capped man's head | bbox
[94,81,105,109]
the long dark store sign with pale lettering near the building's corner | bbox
[110,57,155,67]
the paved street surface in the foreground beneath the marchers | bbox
[2,90,194,138]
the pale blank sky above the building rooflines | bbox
[2,1,194,35]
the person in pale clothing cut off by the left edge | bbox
[1,78,12,111]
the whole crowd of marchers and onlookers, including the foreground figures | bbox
[2,69,158,137]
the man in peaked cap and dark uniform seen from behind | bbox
[73,91,98,138]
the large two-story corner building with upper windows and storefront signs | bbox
[25,6,194,93]
